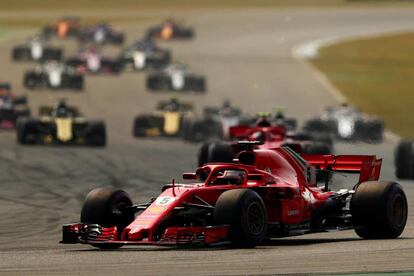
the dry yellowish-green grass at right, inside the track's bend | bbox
[312,33,414,137]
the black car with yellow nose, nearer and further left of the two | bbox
[16,101,106,147]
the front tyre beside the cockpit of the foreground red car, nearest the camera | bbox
[214,189,267,248]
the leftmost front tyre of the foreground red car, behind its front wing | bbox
[80,188,135,249]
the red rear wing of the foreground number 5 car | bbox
[302,154,382,183]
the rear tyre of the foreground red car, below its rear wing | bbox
[350,181,408,239]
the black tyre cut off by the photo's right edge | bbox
[394,141,414,179]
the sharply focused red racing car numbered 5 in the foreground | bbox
[61,142,407,249]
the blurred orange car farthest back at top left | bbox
[42,16,80,38]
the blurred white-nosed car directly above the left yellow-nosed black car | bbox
[23,61,84,90]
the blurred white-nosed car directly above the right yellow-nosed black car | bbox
[146,64,206,92]
